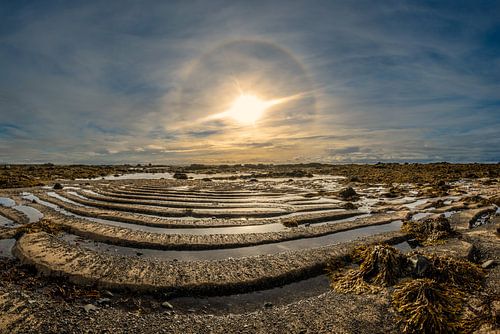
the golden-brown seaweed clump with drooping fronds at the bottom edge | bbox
[392,278,464,333]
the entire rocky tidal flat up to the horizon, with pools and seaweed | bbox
[0,163,500,333]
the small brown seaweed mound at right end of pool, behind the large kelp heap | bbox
[401,216,454,245]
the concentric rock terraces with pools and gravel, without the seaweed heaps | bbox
[0,167,500,333]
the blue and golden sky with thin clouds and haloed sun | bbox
[0,0,500,164]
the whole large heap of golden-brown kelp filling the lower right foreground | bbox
[328,245,484,333]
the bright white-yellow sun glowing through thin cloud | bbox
[226,94,273,125]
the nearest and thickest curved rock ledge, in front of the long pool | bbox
[13,232,405,294]
